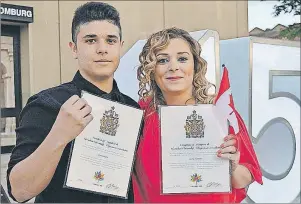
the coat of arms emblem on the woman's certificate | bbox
[184,110,206,138]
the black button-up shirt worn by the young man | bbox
[7,71,139,203]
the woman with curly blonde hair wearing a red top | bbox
[133,28,261,203]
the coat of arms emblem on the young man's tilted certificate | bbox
[99,106,119,136]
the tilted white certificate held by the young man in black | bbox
[64,92,143,199]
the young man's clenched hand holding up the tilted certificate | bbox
[51,95,93,145]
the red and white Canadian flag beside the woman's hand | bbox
[215,65,263,184]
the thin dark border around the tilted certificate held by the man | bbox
[63,90,145,200]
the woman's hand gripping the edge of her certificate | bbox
[217,135,240,172]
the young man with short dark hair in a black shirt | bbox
[7,2,139,203]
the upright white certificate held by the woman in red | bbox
[159,104,231,194]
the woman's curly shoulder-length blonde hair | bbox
[137,27,215,110]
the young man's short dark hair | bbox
[71,2,122,43]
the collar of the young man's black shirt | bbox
[72,71,121,101]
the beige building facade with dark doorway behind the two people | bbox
[0,0,248,150]
